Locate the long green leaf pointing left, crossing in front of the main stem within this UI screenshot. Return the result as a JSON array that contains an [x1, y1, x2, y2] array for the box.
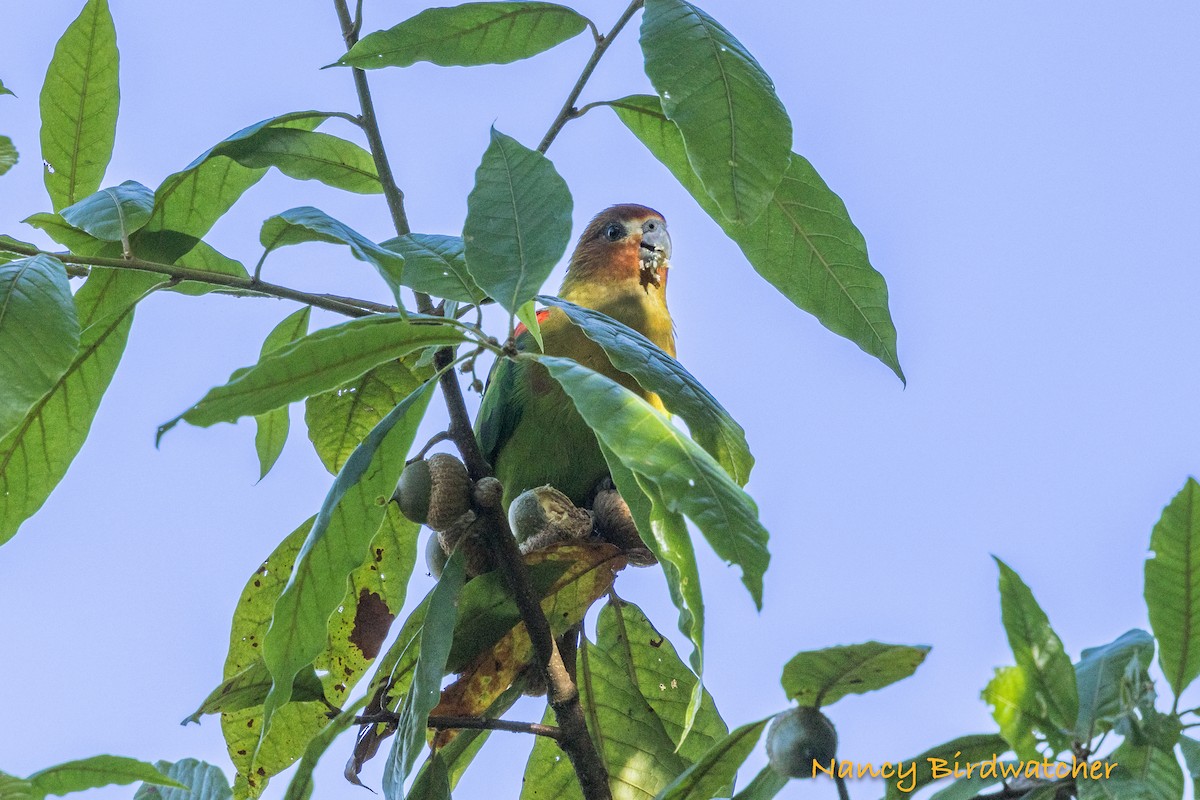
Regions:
[[158, 314, 463, 439]]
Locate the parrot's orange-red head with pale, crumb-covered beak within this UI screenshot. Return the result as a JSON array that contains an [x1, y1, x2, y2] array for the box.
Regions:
[[563, 203, 671, 296]]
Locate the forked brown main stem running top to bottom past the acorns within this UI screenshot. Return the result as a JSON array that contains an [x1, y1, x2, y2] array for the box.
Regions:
[[334, 0, 609, 800]]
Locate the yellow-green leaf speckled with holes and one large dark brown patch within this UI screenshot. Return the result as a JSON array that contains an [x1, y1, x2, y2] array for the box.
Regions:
[[221, 504, 418, 798]]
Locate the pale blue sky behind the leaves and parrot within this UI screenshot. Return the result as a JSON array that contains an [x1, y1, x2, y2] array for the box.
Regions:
[[0, 0, 1200, 800]]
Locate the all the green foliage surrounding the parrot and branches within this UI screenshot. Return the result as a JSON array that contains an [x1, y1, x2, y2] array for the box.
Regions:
[[0, 0, 1200, 800]]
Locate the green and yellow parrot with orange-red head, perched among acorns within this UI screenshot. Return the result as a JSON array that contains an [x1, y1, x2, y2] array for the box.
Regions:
[[475, 204, 676, 509]]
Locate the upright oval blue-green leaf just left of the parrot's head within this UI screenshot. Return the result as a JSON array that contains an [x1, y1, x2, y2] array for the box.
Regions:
[[462, 127, 571, 314]]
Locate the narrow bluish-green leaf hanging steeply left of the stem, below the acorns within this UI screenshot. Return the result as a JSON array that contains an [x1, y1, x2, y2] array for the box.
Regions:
[[383, 549, 467, 800]]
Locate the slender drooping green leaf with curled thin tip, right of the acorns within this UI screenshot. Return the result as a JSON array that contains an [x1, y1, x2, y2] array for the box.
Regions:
[[600, 443, 704, 736]]
